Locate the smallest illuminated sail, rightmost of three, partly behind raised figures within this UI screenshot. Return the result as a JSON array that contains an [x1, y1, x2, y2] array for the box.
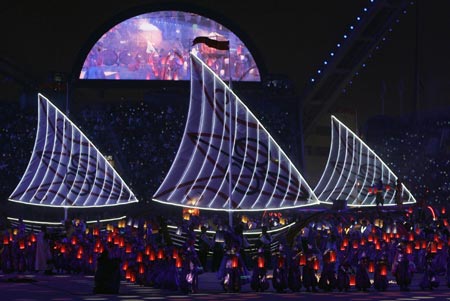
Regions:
[[314, 116, 416, 206]]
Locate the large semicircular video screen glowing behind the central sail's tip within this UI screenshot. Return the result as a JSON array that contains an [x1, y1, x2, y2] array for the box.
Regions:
[[79, 11, 261, 81]]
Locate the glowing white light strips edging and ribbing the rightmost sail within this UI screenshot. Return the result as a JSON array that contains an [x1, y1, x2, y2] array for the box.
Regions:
[[314, 115, 416, 207]]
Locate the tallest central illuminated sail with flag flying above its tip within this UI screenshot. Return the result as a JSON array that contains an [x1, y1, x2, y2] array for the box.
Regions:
[[153, 54, 319, 211]]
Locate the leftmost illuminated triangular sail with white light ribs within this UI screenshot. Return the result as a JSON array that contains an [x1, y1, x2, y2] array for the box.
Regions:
[[9, 94, 138, 208]]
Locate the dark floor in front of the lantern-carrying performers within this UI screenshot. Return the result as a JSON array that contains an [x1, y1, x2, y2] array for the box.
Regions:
[[0, 273, 450, 301]]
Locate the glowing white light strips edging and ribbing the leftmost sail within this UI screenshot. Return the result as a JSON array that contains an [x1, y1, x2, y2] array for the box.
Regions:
[[8, 93, 138, 208]]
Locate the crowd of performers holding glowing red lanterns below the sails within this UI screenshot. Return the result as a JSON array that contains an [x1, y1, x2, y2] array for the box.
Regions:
[[0, 204, 450, 293]]
